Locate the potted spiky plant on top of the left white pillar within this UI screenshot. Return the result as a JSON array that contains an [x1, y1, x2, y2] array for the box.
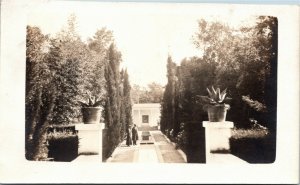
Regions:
[[78, 96, 103, 124]]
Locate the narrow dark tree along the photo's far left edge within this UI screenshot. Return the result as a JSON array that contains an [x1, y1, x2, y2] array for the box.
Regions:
[[25, 26, 57, 160]]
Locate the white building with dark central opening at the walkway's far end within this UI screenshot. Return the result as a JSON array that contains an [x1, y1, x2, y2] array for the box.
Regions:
[[132, 103, 160, 127]]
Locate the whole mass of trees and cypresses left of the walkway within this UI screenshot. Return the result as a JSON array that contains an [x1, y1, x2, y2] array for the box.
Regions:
[[25, 15, 131, 160]]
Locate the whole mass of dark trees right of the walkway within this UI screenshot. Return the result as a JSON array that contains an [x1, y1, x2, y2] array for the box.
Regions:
[[161, 16, 278, 149]]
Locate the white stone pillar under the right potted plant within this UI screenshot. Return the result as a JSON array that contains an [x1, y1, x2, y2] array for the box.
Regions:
[[203, 121, 234, 163]]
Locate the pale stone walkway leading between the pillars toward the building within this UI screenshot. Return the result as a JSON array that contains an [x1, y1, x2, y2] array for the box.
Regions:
[[106, 131, 186, 163]]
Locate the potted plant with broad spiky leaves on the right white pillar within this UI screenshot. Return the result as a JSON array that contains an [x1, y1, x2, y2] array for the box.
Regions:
[[198, 86, 231, 122]]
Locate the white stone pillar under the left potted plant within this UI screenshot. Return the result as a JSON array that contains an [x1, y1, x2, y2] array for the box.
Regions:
[[75, 123, 104, 162]]
